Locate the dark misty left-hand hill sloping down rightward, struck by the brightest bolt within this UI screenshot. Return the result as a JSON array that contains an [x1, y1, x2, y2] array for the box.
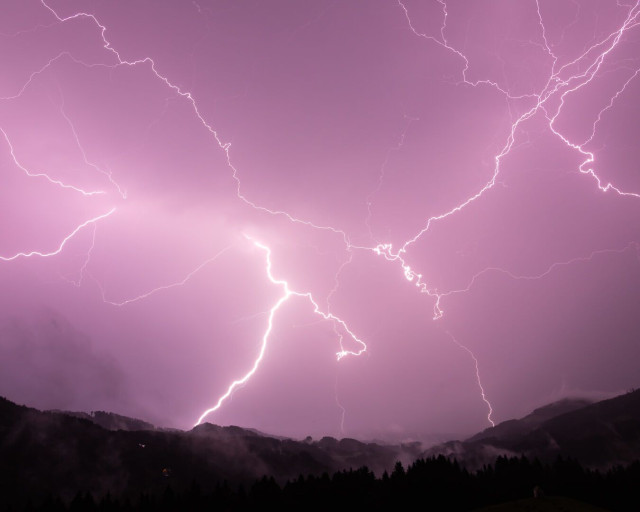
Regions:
[[0, 398, 420, 508]]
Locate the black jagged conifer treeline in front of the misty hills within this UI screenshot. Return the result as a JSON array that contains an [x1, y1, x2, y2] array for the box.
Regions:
[[14, 456, 640, 512]]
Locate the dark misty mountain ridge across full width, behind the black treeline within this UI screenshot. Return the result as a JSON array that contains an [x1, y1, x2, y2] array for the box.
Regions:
[[0, 391, 640, 507]]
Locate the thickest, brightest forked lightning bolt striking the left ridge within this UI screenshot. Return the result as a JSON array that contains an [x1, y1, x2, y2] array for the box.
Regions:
[[195, 237, 367, 425]]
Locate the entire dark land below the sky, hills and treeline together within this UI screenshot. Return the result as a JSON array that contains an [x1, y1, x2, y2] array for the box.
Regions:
[[0, 391, 640, 512]]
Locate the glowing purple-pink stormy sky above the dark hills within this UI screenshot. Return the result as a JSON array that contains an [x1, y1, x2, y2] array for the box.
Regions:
[[0, 0, 640, 439]]
